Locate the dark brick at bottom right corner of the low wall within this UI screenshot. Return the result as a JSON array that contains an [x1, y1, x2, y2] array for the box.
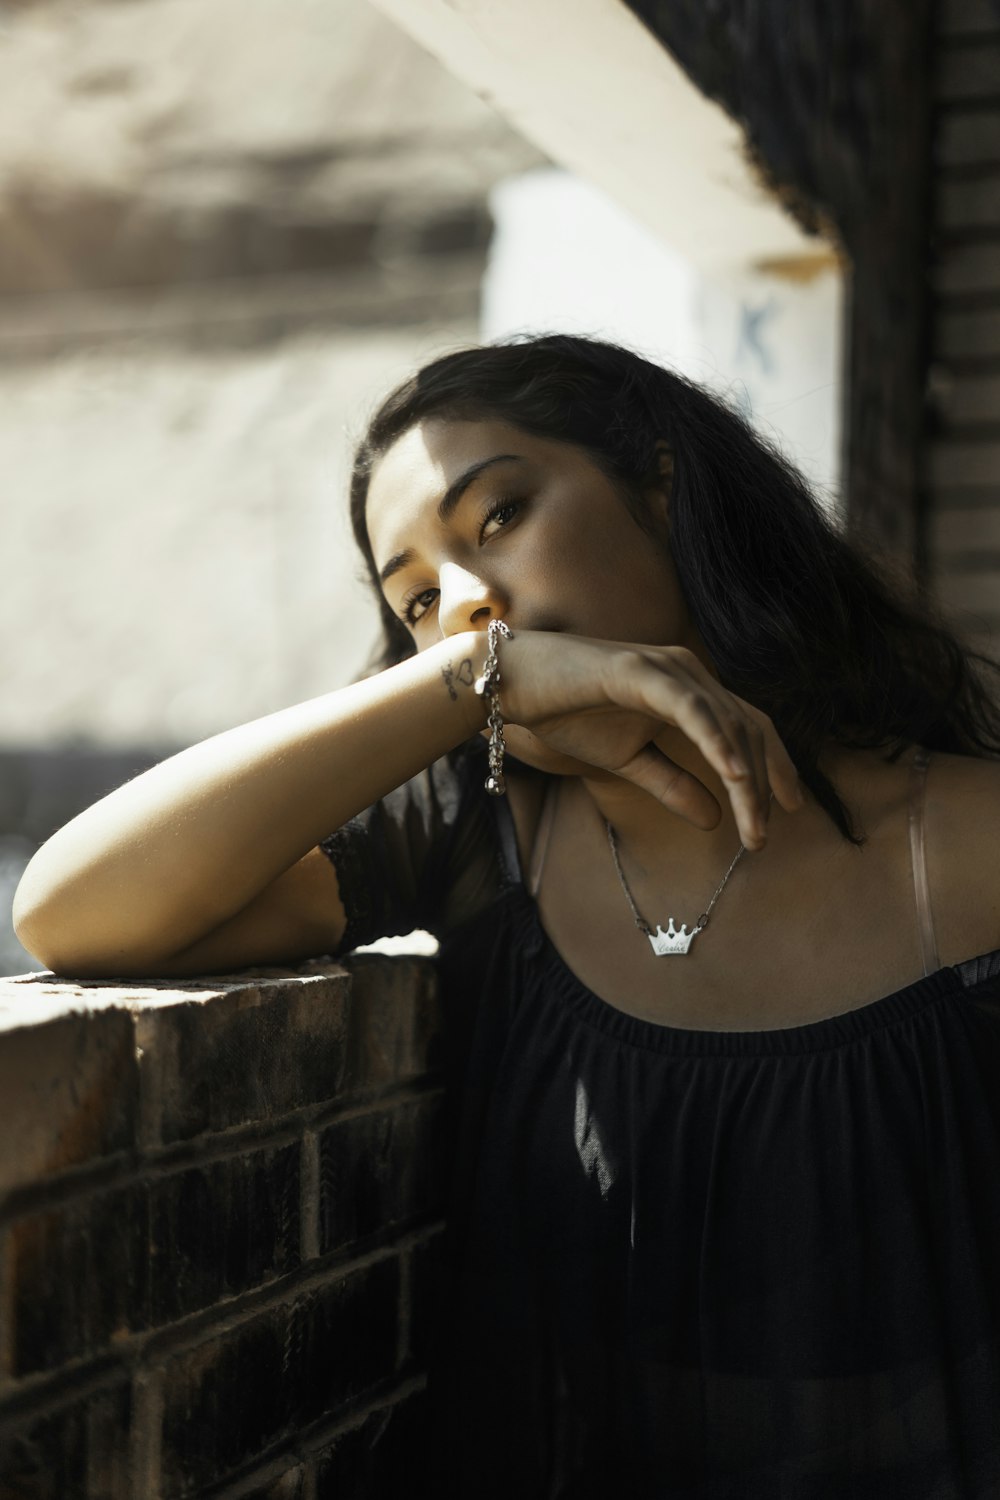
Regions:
[[316, 1391, 427, 1500]]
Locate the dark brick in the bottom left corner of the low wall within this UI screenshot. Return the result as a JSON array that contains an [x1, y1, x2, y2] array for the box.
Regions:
[[0, 1383, 133, 1500]]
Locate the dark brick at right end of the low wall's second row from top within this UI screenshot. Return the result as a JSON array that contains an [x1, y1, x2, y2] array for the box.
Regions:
[[319, 1094, 447, 1256]]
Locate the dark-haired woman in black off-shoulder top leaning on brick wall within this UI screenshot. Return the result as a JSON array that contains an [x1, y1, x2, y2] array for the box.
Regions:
[[16, 336, 1000, 1500]]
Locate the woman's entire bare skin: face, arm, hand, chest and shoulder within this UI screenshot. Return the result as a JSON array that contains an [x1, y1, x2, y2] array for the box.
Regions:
[[15, 422, 1000, 1008]]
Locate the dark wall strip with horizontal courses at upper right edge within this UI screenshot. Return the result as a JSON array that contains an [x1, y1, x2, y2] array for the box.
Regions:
[[925, 0, 1000, 654]]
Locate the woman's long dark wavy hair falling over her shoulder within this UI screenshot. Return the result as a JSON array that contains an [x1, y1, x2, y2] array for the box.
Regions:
[[351, 333, 1000, 846]]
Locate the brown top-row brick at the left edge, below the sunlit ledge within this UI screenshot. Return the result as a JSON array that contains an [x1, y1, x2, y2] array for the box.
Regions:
[[0, 1008, 138, 1194]]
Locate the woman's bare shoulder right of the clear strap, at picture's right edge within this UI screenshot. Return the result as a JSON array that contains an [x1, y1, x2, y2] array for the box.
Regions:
[[925, 752, 1000, 965]]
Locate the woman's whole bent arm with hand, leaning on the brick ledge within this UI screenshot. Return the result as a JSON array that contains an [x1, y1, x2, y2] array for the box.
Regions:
[[13, 630, 801, 975]]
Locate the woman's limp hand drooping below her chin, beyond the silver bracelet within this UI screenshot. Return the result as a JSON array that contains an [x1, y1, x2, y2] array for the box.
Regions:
[[499, 630, 804, 848]]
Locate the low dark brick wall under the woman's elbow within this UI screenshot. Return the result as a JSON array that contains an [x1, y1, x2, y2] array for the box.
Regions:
[[0, 954, 444, 1500]]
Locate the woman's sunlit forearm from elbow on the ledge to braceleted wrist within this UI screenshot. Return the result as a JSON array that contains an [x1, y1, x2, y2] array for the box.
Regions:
[[13, 632, 486, 968]]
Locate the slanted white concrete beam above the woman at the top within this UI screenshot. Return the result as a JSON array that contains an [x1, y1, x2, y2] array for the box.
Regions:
[[372, 0, 823, 267]]
